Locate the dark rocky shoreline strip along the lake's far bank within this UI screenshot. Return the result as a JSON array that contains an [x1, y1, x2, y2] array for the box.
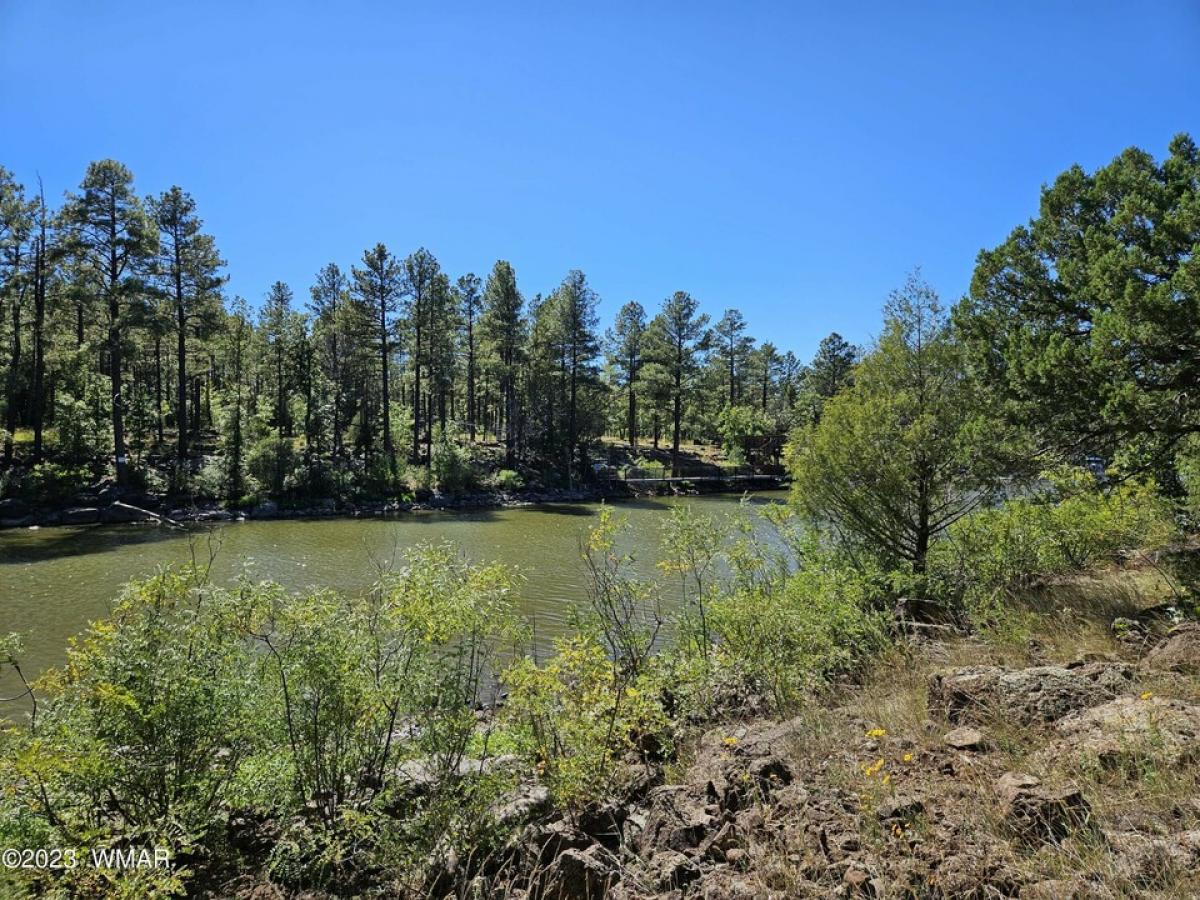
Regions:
[[0, 476, 785, 529]]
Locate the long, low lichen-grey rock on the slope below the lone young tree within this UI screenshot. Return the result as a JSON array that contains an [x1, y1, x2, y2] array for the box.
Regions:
[[929, 662, 1133, 725]]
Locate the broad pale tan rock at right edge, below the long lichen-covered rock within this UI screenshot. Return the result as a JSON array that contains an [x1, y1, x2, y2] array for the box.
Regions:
[[1045, 696, 1200, 767]]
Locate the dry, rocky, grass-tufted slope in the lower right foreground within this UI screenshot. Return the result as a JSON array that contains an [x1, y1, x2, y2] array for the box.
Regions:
[[225, 574, 1200, 900]]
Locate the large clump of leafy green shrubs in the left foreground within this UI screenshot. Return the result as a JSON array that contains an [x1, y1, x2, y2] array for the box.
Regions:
[[0, 547, 516, 896]]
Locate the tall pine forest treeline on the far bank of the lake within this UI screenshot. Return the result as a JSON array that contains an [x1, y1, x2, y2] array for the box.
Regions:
[[0, 160, 859, 500]]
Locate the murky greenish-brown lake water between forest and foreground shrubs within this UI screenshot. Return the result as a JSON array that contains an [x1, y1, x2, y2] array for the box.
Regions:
[[0, 491, 787, 691]]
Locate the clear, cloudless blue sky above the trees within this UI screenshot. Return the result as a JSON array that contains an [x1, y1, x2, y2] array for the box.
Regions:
[[0, 0, 1200, 358]]
